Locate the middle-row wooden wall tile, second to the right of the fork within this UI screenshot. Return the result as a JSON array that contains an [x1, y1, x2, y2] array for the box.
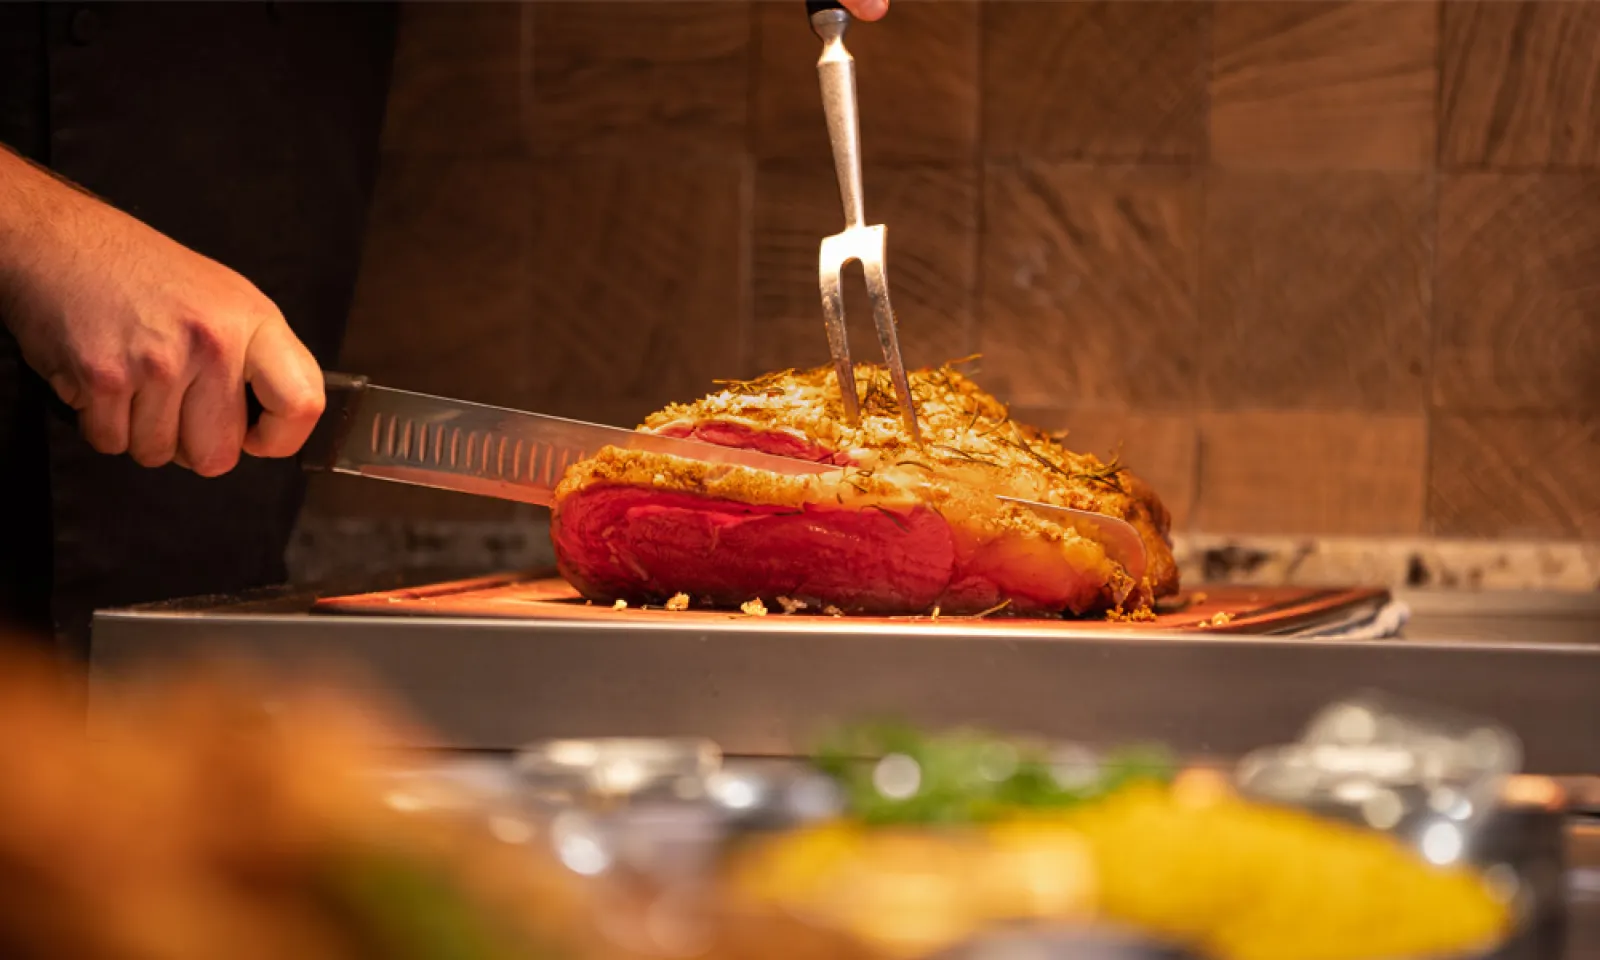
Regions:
[[1195, 171, 1432, 411]]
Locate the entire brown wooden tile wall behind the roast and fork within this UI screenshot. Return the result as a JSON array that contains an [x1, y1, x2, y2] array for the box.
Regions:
[[302, 0, 1600, 541]]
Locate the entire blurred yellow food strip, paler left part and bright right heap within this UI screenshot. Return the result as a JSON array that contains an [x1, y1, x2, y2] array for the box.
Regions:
[[733, 781, 1510, 960]]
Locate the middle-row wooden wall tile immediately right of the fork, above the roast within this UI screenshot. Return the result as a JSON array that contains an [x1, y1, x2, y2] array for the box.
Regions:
[[979, 163, 1202, 410]]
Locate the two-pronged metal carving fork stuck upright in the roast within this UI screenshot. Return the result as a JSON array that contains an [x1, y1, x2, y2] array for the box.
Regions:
[[805, 0, 922, 443]]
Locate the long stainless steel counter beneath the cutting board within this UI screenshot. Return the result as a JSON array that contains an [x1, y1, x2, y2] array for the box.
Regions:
[[91, 582, 1600, 774]]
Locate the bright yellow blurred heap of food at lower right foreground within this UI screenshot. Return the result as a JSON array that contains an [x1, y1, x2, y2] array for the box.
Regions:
[[1064, 784, 1510, 960]]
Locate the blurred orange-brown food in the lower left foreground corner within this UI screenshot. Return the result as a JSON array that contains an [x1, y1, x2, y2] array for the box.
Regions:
[[0, 658, 598, 960]]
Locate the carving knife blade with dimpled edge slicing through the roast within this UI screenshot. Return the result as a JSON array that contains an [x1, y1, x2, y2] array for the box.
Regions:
[[299, 373, 1147, 581]]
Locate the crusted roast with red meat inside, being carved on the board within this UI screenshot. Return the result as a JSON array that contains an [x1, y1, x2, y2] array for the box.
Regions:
[[552, 363, 1178, 616]]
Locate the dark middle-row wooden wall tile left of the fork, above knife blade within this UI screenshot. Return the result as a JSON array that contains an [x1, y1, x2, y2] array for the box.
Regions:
[[520, 158, 750, 426]]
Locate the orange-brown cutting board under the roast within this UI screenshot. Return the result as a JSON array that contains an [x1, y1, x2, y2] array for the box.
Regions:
[[314, 574, 1389, 634]]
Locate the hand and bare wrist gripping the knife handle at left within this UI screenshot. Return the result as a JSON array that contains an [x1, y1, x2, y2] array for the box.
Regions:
[[0, 150, 323, 477]]
